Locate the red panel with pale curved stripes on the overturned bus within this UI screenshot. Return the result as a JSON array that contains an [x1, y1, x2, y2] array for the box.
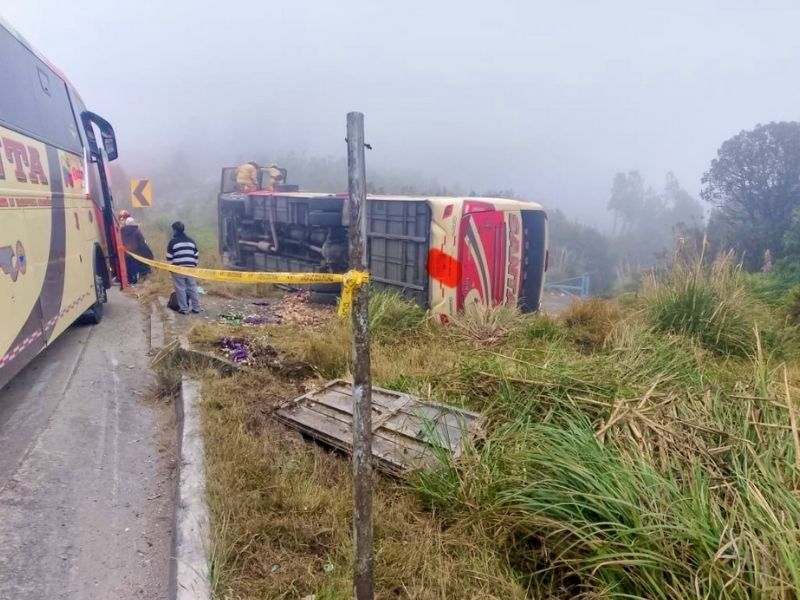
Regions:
[[456, 201, 506, 310]]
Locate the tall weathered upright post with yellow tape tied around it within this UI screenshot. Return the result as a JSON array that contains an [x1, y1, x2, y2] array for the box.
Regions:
[[347, 112, 375, 600]]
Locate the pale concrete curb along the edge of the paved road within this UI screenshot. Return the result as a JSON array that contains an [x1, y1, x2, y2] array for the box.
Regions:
[[170, 375, 211, 600]]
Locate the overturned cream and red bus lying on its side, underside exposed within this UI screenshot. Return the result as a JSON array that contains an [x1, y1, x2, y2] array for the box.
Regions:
[[218, 168, 547, 321]]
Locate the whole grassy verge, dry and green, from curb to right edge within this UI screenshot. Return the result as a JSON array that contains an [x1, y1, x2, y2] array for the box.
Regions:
[[193, 256, 800, 600]]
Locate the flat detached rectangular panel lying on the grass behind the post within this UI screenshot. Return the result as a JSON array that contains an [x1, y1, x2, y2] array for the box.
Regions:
[[273, 379, 483, 475]]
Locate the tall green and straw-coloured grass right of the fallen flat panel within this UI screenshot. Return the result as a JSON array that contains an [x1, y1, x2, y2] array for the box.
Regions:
[[412, 257, 800, 600]]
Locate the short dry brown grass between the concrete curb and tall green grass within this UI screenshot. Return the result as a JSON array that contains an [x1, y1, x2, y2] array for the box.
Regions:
[[203, 374, 526, 600]]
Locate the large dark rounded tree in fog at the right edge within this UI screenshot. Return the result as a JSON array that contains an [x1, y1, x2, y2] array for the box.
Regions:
[[701, 122, 800, 270]]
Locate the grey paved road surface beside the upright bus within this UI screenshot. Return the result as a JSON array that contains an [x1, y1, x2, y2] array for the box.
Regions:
[[0, 293, 175, 600]]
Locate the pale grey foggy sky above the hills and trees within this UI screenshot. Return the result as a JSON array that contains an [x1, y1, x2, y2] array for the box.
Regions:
[[0, 0, 800, 223]]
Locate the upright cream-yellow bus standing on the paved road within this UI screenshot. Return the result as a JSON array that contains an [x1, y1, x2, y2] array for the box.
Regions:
[[0, 20, 124, 388]]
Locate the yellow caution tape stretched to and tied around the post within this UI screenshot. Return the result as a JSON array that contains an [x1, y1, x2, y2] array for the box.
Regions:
[[128, 252, 369, 317]]
